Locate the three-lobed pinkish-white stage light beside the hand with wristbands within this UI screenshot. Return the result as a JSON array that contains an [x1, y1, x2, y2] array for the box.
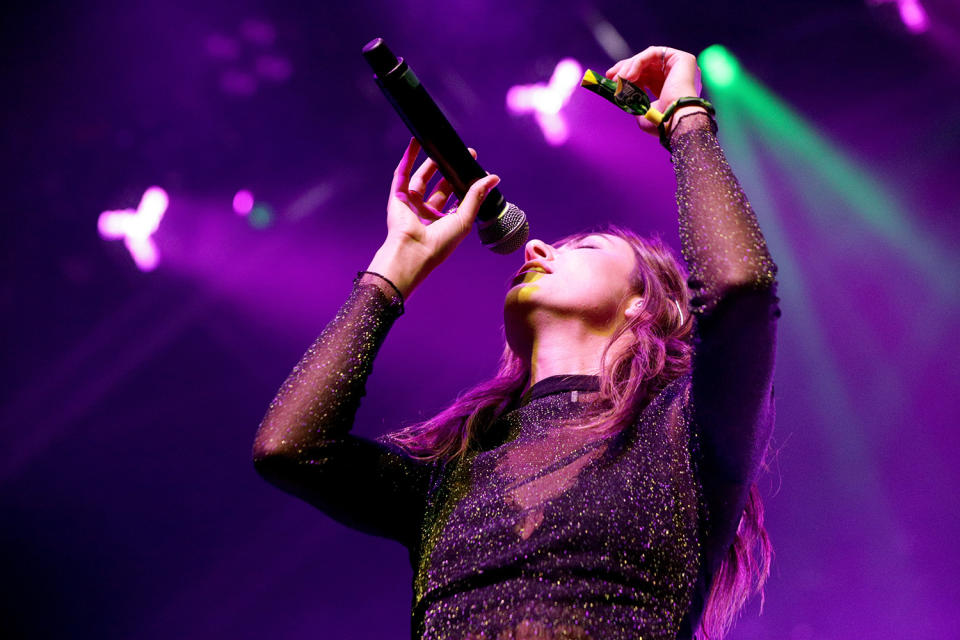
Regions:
[[507, 58, 583, 145]]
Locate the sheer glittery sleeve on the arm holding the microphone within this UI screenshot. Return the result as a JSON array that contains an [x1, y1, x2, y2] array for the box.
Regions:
[[253, 275, 433, 547]]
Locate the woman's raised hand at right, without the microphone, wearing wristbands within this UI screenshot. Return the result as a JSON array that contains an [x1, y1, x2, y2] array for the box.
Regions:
[[605, 47, 705, 135]]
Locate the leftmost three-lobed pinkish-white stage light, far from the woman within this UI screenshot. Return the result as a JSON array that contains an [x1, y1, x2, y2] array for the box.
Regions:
[[97, 187, 170, 271]]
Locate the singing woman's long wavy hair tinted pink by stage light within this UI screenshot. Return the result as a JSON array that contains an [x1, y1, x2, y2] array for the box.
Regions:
[[386, 224, 773, 640]]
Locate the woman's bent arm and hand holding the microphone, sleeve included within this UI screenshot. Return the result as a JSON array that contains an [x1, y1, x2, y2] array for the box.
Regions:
[[253, 142, 496, 546]]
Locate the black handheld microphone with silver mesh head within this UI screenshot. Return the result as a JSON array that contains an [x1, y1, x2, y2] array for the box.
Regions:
[[363, 38, 530, 254]]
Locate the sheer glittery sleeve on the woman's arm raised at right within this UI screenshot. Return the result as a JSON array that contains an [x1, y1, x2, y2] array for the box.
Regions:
[[672, 114, 780, 562]]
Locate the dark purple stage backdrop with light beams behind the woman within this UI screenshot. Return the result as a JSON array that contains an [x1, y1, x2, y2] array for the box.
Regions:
[[0, 0, 960, 640]]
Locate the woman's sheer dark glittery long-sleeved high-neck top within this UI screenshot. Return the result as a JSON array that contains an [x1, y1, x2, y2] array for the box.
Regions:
[[254, 116, 779, 640]]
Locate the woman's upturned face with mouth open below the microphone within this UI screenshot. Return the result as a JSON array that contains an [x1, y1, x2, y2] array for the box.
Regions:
[[504, 233, 639, 331]]
